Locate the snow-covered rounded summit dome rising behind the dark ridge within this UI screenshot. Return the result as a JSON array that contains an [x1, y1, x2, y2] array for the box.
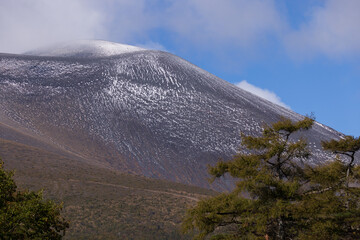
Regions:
[[25, 40, 145, 58]]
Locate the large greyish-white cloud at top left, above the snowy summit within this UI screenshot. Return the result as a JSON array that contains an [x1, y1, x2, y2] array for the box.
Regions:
[[0, 0, 156, 53]]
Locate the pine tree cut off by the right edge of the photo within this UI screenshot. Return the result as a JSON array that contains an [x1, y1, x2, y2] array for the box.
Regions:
[[302, 136, 360, 239]]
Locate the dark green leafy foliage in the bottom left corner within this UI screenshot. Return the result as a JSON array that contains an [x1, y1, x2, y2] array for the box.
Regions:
[[0, 159, 69, 239]]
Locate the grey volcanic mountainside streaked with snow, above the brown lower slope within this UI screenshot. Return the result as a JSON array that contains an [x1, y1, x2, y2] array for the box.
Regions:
[[0, 41, 341, 189]]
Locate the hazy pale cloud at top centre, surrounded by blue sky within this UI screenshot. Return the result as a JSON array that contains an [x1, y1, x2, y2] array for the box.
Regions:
[[164, 0, 282, 48]]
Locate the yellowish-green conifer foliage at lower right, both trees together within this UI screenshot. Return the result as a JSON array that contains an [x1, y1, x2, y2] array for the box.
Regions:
[[183, 118, 360, 239]]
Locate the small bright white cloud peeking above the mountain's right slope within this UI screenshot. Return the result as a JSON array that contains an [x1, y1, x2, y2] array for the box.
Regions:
[[235, 80, 291, 109]]
